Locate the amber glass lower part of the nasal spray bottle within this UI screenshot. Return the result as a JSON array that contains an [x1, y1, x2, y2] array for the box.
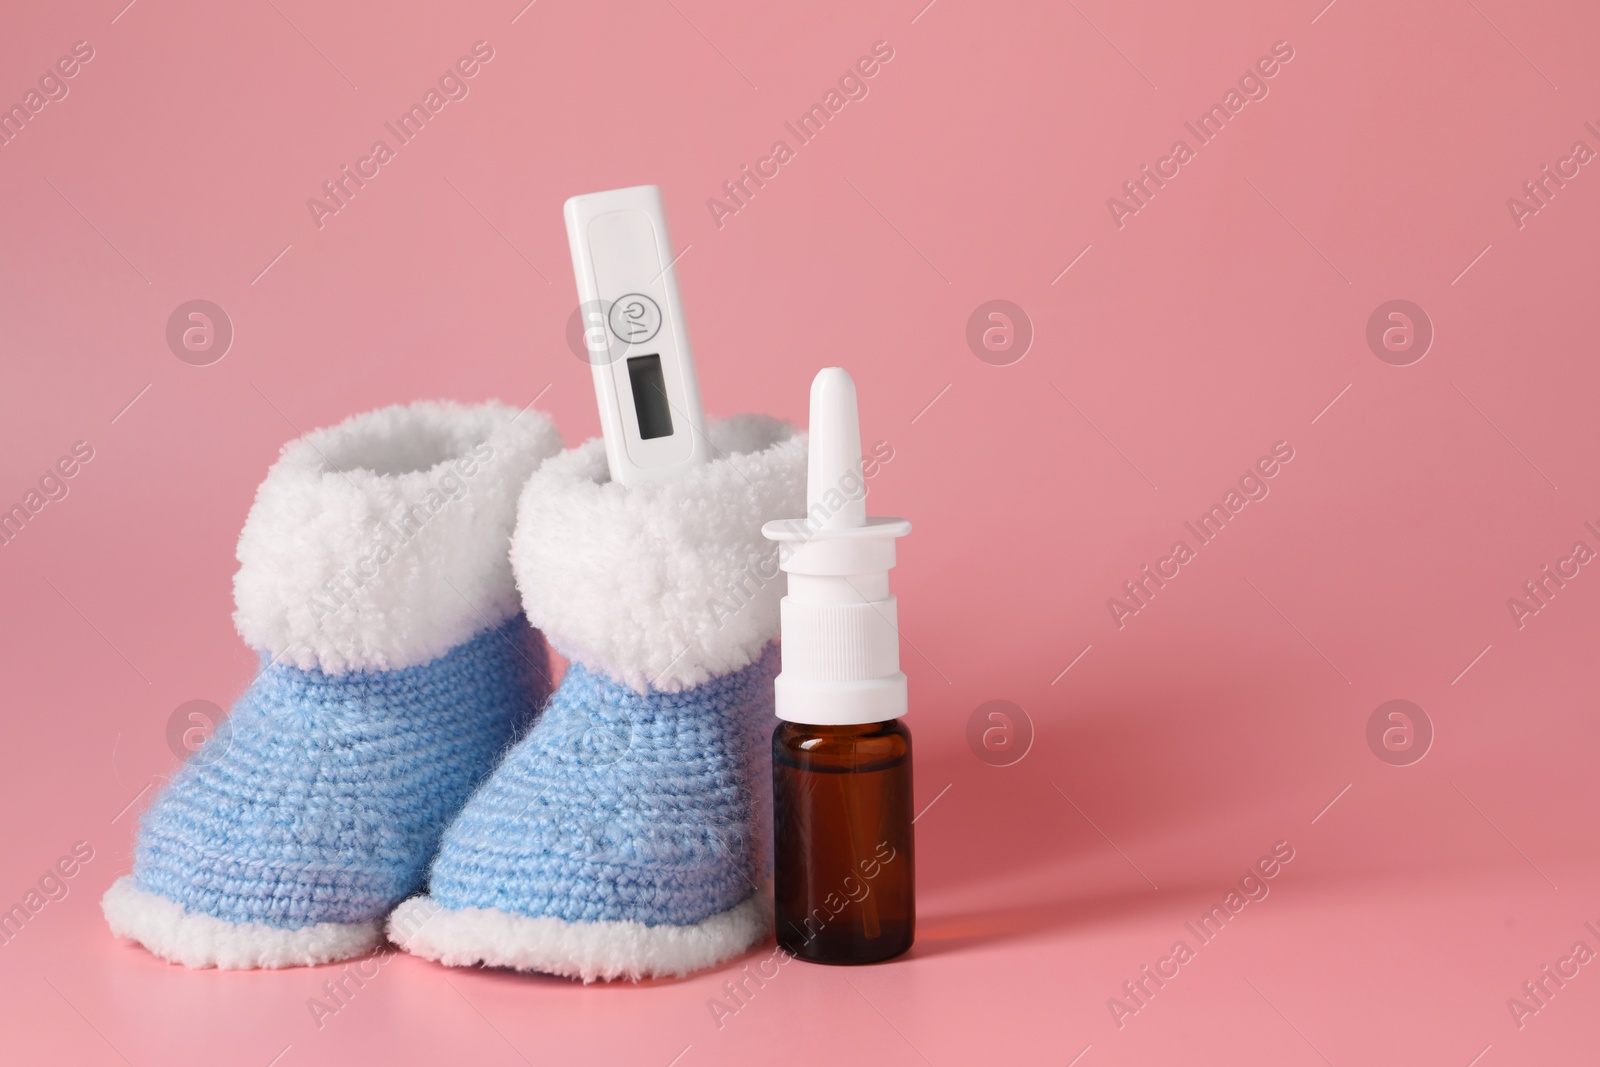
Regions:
[[773, 718, 917, 963]]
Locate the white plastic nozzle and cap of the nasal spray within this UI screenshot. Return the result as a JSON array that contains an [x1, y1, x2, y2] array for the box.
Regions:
[[762, 366, 910, 726]]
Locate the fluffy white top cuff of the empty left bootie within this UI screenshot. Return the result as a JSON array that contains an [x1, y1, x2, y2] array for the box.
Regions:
[[234, 402, 562, 673]]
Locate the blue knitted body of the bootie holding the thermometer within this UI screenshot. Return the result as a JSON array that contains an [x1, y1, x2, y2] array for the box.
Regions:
[[429, 645, 779, 926]]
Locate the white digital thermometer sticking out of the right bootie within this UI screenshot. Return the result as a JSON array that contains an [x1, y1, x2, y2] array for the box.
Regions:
[[563, 186, 710, 485]]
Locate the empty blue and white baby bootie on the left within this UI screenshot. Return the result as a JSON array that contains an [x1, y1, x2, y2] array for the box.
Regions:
[[102, 403, 560, 968]]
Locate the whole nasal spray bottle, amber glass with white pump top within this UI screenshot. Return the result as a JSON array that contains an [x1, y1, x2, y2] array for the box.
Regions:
[[762, 366, 917, 963]]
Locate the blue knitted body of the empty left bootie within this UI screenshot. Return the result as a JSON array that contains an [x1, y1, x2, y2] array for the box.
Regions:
[[133, 614, 549, 928]]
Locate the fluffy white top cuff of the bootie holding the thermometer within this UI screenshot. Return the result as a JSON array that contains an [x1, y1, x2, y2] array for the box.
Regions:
[[510, 416, 806, 693]]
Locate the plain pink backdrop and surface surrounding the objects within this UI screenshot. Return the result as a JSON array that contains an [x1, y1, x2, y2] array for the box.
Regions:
[[0, 0, 1600, 1067]]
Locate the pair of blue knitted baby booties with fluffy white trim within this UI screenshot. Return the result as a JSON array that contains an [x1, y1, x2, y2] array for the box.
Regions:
[[102, 402, 806, 982]]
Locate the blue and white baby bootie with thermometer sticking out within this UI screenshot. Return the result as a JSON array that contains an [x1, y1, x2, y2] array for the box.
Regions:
[[389, 416, 806, 982]]
